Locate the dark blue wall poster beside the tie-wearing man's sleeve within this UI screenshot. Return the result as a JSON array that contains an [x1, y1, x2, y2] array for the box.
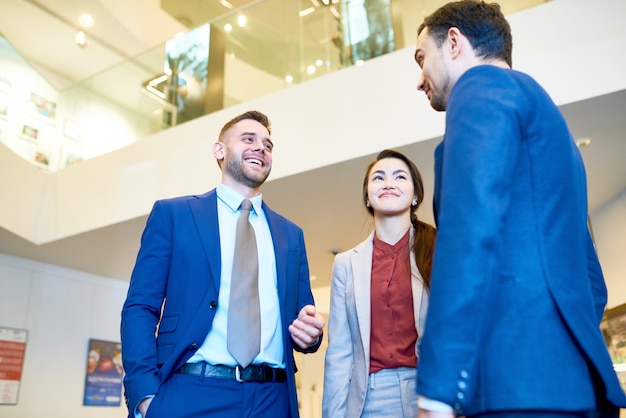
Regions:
[[83, 339, 124, 406]]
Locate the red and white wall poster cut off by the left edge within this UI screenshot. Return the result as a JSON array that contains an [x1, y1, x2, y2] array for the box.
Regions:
[[0, 327, 28, 405]]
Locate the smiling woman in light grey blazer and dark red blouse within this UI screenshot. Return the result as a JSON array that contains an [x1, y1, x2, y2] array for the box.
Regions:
[[322, 150, 436, 418]]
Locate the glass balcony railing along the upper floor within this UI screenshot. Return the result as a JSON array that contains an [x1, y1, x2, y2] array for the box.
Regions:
[[0, 0, 546, 171]]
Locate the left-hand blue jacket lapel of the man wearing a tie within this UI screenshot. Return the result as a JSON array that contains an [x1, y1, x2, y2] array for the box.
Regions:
[[189, 189, 222, 289]]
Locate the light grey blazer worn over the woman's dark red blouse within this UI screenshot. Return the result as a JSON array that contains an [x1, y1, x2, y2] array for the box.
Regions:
[[322, 229, 428, 418]]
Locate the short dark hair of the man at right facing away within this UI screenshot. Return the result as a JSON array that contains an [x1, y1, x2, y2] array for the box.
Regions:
[[417, 0, 513, 67]]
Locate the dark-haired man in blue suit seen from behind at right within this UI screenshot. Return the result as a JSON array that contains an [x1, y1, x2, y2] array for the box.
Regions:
[[415, 0, 626, 418]]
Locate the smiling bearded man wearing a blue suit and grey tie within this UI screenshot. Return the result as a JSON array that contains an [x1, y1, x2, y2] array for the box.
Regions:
[[121, 111, 324, 418]]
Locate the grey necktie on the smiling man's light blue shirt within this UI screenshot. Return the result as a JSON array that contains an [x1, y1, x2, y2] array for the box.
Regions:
[[227, 199, 261, 367]]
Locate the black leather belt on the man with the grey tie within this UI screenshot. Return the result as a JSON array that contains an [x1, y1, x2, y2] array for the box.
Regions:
[[176, 363, 287, 382]]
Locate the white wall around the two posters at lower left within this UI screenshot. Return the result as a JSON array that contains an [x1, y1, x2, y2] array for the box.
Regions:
[[0, 254, 128, 418]]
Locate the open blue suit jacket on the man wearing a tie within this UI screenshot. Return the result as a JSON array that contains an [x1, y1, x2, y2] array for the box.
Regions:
[[121, 190, 321, 417]]
